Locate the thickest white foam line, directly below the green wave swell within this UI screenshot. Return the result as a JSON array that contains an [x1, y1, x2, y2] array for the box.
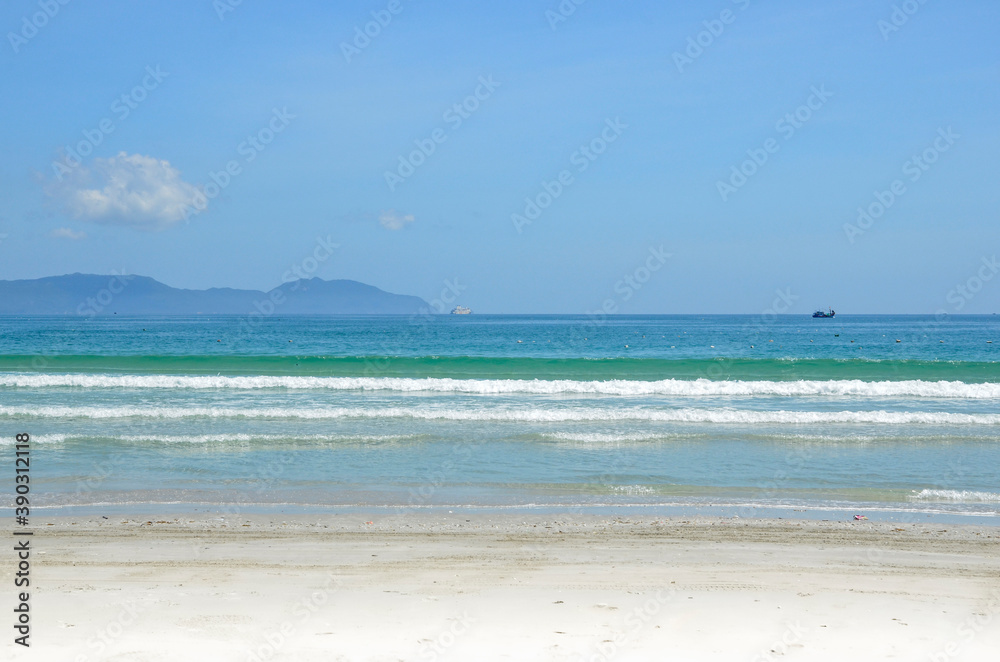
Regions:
[[0, 373, 1000, 400]]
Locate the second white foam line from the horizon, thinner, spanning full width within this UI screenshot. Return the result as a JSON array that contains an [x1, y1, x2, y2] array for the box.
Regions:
[[0, 406, 1000, 426]]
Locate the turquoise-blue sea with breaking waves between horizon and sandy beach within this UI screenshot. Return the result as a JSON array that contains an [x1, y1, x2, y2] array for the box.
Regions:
[[0, 314, 1000, 525]]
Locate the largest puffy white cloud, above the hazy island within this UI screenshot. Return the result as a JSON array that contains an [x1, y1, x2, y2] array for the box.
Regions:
[[48, 152, 200, 230]]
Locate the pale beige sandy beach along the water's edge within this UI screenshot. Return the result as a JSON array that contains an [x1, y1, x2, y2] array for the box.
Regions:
[[0, 513, 1000, 662]]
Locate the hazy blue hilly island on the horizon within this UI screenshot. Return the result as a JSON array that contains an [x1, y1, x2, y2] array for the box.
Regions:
[[0, 273, 432, 317]]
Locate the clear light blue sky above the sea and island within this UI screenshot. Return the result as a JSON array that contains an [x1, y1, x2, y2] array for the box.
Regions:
[[0, 0, 1000, 313]]
